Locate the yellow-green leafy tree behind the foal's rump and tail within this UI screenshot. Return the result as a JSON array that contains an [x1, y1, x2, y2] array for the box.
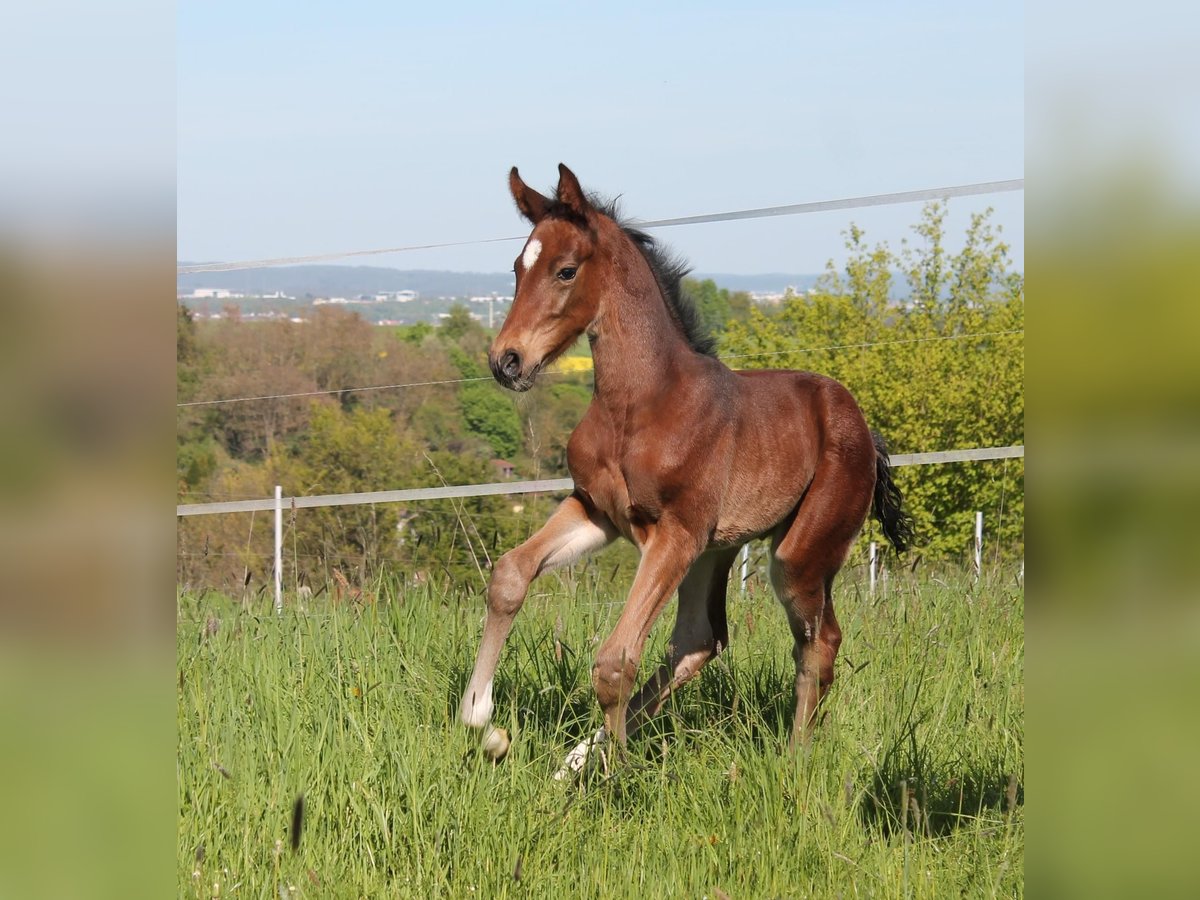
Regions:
[[721, 203, 1025, 558]]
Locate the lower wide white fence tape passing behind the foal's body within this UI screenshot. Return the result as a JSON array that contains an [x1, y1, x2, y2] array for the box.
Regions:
[[175, 444, 1025, 516]]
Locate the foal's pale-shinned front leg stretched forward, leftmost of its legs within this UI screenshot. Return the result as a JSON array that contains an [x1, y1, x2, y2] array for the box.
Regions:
[[458, 494, 617, 760]]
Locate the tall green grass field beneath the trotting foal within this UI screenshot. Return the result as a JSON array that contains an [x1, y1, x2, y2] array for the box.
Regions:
[[176, 572, 1025, 900]]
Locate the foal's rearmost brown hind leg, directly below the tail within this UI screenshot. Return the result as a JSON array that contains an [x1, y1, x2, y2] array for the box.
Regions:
[[770, 472, 871, 746]]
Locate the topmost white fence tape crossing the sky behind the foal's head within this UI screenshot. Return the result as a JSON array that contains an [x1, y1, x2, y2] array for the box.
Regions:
[[175, 178, 1025, 275]]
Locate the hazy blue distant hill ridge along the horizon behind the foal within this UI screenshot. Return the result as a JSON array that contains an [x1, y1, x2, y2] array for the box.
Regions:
[[178, 265, 817, 299]]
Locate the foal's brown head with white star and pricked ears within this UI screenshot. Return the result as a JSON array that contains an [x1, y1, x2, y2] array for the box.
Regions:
[[487, 164, 600, 391]]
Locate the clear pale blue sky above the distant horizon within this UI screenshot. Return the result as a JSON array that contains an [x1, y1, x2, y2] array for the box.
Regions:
[[176, 0, 1024, 274]]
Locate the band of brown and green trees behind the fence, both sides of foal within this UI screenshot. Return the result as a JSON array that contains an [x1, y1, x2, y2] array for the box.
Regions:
[[176, 204, 1024, 593]]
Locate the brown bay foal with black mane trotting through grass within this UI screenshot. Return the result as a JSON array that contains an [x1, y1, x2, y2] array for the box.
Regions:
[[461, 166, 911, 776]]
